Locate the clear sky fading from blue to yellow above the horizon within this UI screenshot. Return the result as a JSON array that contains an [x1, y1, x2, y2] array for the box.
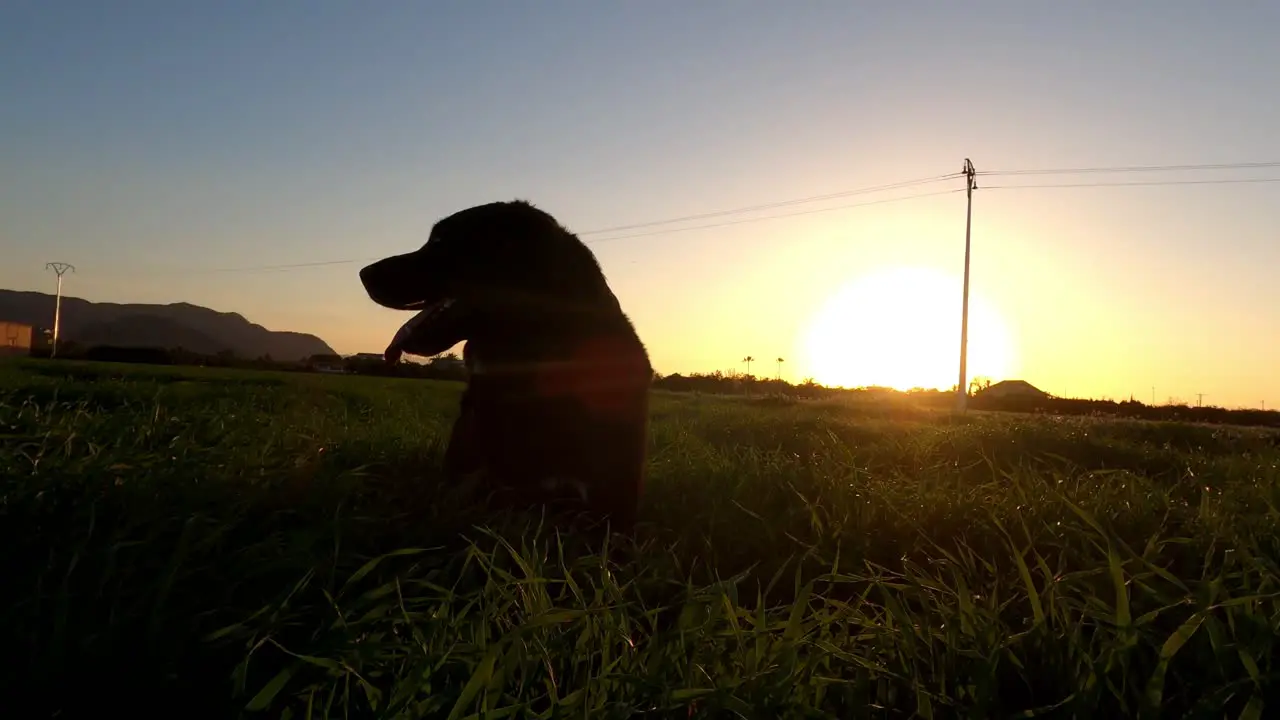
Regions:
[[0, 0, 1280, 406]]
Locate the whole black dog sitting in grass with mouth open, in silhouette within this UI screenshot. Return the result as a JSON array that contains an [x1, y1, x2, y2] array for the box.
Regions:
[[361, 201, 653, 528]]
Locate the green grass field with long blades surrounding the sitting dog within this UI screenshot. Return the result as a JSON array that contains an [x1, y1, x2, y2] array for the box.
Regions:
[[0, 361, 1280, 717]]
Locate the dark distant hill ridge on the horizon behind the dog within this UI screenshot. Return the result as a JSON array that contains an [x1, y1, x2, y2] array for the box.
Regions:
[[0, 290, 335, 360]]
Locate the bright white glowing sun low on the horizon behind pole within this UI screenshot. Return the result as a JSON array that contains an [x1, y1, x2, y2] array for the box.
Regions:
[[805, 268, 1015, 389]]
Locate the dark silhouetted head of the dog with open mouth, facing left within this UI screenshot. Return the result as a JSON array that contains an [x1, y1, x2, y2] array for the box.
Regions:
[[360, 200, 617, 355]]
